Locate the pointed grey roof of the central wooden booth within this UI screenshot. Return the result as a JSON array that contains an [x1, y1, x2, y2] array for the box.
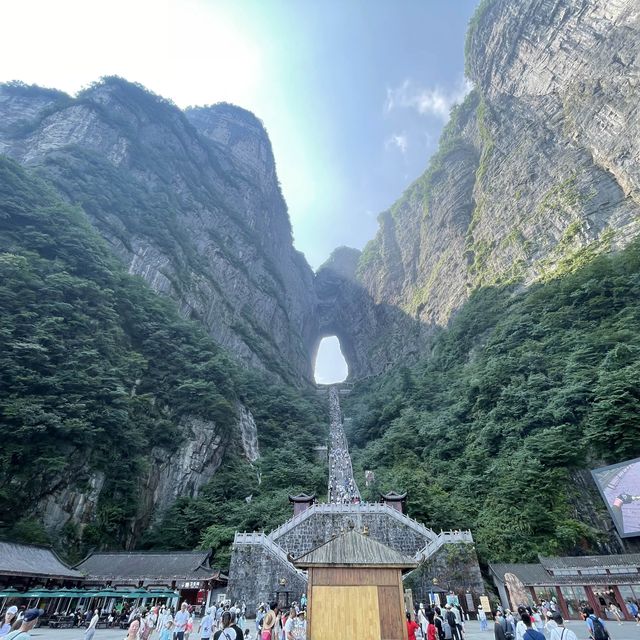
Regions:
[[294, 531, 417, 569]]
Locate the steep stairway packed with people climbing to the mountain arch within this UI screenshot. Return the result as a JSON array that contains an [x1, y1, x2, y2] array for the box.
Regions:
[[328, 387, 360, 504]]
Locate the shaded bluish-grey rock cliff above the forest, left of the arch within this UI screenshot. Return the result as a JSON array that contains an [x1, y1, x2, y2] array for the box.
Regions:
[[0, 79, 314, 383]]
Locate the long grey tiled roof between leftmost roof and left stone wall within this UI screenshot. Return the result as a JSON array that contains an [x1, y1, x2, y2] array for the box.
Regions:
[[76, 550, 219, 581]]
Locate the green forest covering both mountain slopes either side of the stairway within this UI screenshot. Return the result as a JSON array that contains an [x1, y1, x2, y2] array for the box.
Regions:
[[0, 148, 640, 567]]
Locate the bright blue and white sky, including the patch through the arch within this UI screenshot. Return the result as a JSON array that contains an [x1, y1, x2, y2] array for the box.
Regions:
[[0, 0, 477, 381]]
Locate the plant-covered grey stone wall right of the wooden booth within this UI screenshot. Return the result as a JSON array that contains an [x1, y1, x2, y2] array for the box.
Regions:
[[404, 543, 485, 610]]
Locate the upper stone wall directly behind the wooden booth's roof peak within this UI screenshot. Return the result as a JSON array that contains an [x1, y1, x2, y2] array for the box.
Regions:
[[273, 507, 429, 558]]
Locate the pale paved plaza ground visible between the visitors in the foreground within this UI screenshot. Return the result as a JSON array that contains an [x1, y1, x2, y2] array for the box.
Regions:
[[31, 620, 640, 640]]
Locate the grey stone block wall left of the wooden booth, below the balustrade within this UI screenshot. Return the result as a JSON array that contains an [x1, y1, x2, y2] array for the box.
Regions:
[[227, 544, 307, 614]]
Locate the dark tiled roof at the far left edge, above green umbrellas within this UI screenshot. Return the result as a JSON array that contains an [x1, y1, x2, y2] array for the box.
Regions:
[[0, 541, 82, 579]]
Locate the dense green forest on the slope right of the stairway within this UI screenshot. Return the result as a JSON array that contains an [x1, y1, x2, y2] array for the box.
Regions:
[[345, 242, 640, 561]]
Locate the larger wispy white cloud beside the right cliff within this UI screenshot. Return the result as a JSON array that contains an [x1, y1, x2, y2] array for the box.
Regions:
[[384, 78, 472, 121]]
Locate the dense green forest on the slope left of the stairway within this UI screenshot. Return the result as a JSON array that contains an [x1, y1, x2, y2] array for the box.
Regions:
[[0, 157, 325, 563]]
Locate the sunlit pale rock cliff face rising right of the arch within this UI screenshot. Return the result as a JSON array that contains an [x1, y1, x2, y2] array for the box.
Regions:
[[321, 0, 640, 372]]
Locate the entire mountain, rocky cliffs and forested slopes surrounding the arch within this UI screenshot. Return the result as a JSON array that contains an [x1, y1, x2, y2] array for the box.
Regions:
[[0, 0, 640, 565]]
